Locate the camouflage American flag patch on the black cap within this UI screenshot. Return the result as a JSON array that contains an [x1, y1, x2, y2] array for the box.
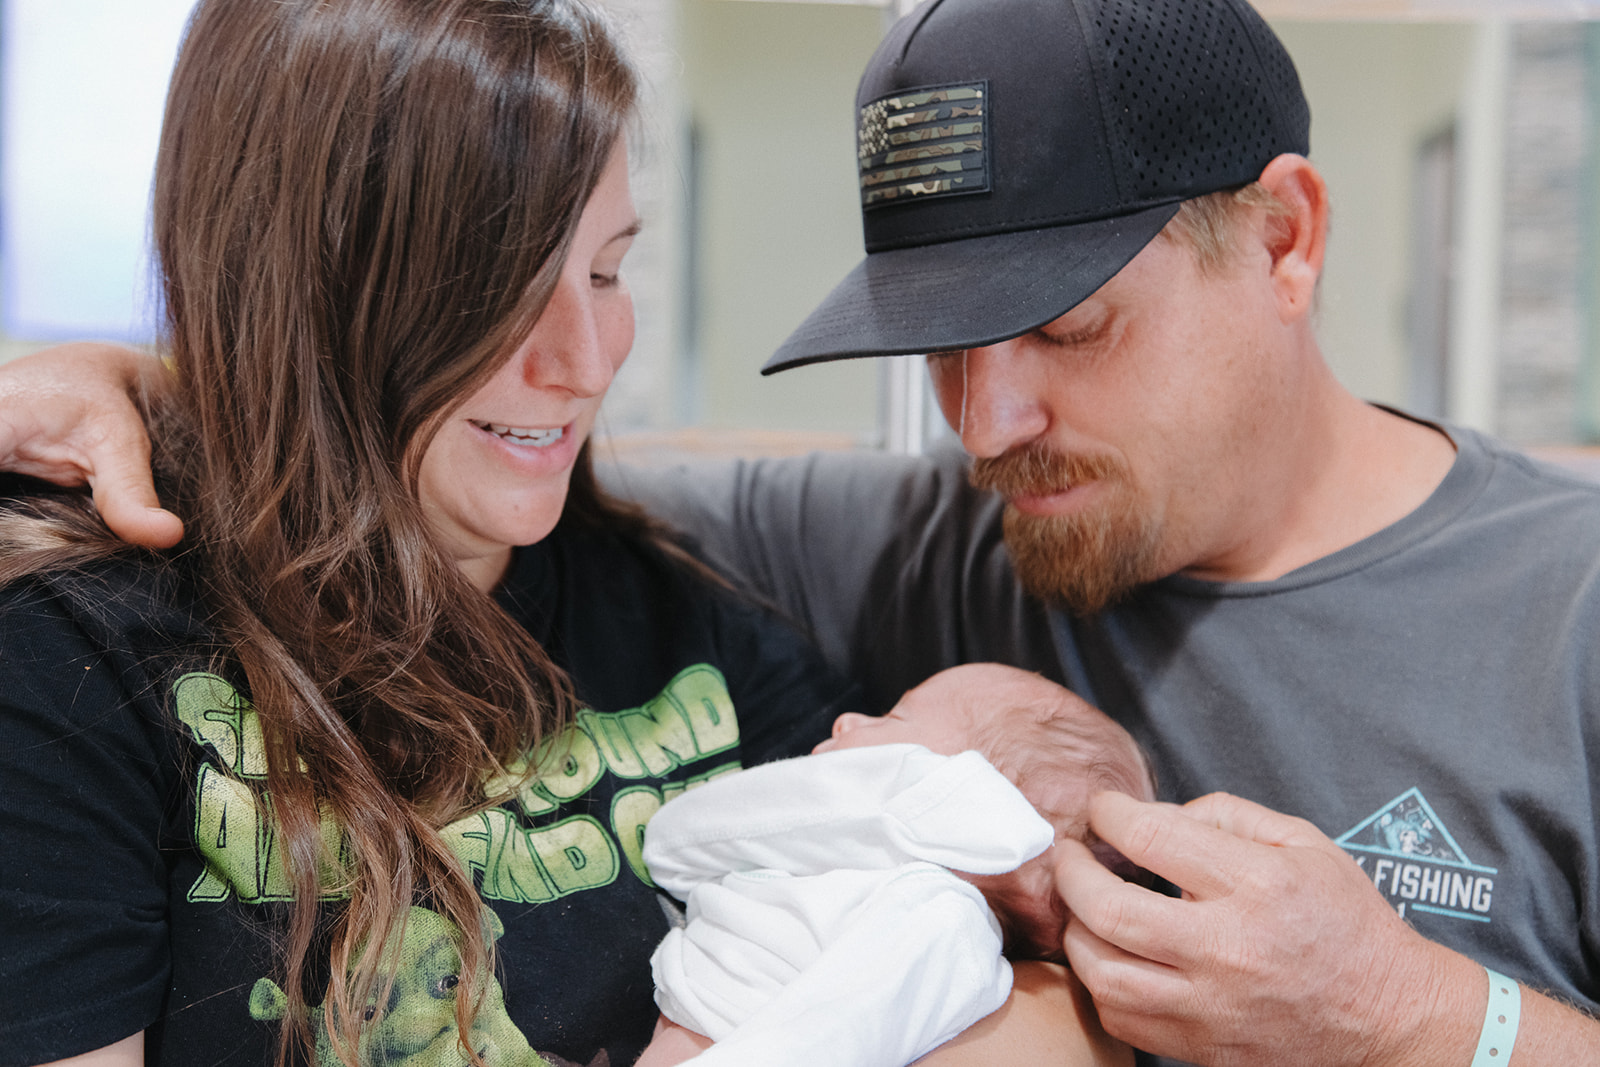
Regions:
[[856, 82, 989, 208]]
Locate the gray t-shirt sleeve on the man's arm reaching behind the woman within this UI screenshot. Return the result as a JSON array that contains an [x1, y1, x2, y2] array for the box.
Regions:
[[606, 451, 1062, 712]]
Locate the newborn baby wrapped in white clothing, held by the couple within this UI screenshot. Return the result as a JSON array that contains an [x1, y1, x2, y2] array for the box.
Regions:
[[638, 664, 1155, 1067]]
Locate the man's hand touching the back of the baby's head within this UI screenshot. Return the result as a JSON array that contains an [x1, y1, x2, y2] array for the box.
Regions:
[[1056, 793, 1478, 1067]]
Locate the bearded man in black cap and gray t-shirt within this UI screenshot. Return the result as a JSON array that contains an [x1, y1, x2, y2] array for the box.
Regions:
[[0, 0, 1600, 1067]]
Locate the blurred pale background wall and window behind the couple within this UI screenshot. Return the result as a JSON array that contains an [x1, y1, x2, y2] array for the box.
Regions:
[[0, 0, 1600, 446]]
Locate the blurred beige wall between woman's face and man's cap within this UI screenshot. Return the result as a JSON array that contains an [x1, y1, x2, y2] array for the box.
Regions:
[[682, 0, 885, 437]]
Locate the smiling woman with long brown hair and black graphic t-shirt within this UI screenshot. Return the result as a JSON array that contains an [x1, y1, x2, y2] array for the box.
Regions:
[[0, 0, 840, 1065]]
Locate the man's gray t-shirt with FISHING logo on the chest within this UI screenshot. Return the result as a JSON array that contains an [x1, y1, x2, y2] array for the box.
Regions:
[[601, 430, 1600, 1062]]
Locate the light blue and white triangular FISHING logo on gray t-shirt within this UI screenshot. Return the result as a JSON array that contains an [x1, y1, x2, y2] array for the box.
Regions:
[[1334, 789, 1498, 923]]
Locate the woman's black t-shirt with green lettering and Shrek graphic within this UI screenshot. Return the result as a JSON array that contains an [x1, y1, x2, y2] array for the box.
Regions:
[[0, 511, 856, 1067]]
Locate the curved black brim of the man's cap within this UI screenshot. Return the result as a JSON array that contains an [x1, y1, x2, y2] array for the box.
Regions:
[[762, 203, 1179, 374]]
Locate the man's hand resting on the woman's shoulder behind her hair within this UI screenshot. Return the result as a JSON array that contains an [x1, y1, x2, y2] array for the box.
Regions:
[[0, 342, 184, 549]]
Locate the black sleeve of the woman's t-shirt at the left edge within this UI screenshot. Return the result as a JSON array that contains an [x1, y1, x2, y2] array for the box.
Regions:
[[0, 582, 168, 1064]]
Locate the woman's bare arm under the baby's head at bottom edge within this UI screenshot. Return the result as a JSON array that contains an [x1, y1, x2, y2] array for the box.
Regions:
[[917, 960, 1133, 1067]]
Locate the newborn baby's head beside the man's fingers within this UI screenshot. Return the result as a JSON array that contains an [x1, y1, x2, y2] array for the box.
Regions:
[[816, 664, 1155, 960]]
